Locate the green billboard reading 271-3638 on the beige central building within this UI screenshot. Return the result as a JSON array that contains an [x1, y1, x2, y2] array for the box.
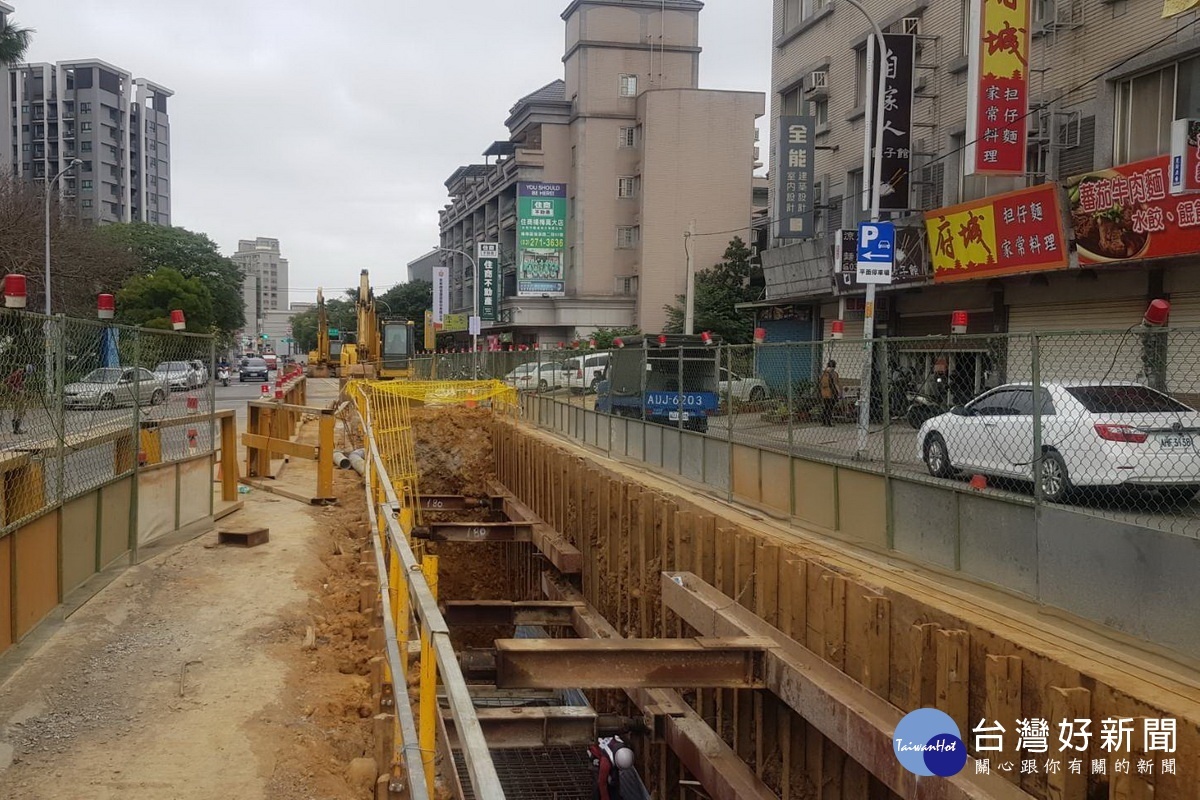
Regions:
[[517, 182, 566, 297]]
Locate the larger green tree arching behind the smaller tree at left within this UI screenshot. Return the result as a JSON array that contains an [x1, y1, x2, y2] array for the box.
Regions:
[[98, 222, 246, 347]]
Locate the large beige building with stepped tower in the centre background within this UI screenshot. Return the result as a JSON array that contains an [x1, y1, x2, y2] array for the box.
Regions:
[[440, 0, 766, 347]]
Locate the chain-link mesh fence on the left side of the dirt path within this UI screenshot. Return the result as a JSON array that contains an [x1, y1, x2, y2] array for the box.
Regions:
[[0, 309, 215, 528]]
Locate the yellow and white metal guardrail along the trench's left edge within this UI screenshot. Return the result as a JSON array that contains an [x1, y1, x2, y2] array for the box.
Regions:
[[347, 381, 505, 800]]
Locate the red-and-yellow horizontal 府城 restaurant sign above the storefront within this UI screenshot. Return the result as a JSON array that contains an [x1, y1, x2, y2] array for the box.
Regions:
[[925, 184, 1067, 283]]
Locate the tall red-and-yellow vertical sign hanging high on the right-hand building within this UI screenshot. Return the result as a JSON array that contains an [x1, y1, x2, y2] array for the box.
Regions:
[[966, 0, 1032, 175]]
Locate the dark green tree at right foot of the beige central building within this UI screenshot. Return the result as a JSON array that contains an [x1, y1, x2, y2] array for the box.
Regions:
[[664, 236, 755, 344]]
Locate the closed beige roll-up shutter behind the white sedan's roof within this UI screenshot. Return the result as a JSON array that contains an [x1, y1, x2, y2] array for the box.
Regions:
[[1007, 297, 1146, 381]]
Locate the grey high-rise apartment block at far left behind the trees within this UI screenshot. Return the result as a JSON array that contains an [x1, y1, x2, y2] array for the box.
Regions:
[[0, 44, 174, 225]]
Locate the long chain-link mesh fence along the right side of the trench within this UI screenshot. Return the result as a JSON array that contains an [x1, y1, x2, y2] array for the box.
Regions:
[[419, 326, 1200, 536]]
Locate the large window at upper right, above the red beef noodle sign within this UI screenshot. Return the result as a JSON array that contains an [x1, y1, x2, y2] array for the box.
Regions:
[[1112, 56, 1200, 164]]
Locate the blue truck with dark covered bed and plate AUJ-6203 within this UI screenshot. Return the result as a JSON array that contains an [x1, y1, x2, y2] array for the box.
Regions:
[[596, 333, 719, 433]]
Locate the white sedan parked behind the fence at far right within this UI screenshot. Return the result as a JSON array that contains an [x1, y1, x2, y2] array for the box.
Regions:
[[917, 381, 1200, 503]]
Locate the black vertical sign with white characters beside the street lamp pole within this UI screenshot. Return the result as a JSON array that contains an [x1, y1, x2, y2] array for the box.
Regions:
[[863, 34, 917, 211]]
